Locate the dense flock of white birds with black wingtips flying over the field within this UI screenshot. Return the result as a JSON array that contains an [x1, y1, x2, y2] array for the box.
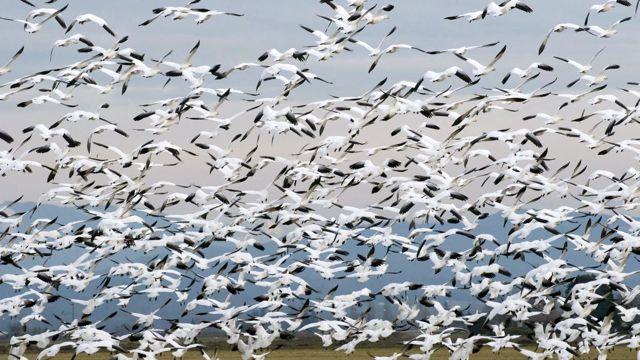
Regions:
[[0, 0, 640, 360]]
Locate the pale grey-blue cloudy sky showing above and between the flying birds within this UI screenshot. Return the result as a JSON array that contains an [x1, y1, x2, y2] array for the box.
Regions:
[[0, 0, 640, 338]]
